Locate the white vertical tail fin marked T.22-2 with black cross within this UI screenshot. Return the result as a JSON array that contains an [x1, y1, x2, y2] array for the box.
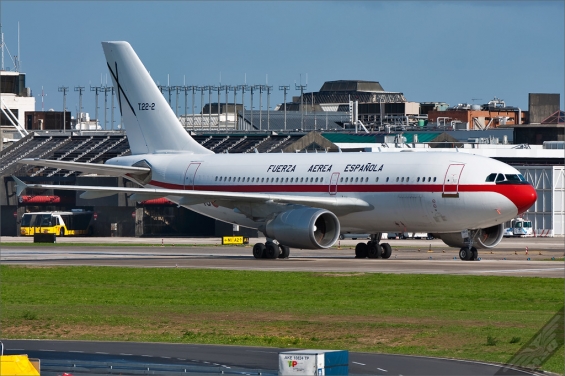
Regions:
[[102, 42, 213, 154]]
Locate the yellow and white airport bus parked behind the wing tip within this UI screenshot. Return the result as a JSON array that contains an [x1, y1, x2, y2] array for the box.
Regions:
[[20, 210, 94, 236]]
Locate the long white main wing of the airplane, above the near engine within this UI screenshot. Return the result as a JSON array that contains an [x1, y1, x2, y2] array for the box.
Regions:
[[12, 176, 373, 214]]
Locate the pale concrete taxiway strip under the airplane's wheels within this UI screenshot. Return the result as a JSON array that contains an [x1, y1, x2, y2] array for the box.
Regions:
[[0, 238, 565, 278]]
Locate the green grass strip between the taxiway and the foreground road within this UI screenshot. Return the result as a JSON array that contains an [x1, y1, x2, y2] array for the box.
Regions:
[[0, 266, 564, 373]]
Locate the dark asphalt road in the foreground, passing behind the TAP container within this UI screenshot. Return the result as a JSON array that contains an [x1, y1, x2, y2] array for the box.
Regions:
[[3, 340, 533, 376]]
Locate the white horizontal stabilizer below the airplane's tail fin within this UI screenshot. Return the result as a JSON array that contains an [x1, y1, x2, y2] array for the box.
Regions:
[[18, 158, 151, 176]]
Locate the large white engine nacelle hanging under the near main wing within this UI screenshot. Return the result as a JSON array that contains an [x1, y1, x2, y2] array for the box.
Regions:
[[261, 208, 340, 249]]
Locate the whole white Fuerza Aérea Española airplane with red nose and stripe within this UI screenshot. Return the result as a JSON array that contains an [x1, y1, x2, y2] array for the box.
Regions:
[[14, 42, 537, 260]]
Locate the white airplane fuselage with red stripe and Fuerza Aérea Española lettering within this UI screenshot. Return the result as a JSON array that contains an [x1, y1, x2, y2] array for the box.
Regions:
[[107, 152, 533, 233]]
